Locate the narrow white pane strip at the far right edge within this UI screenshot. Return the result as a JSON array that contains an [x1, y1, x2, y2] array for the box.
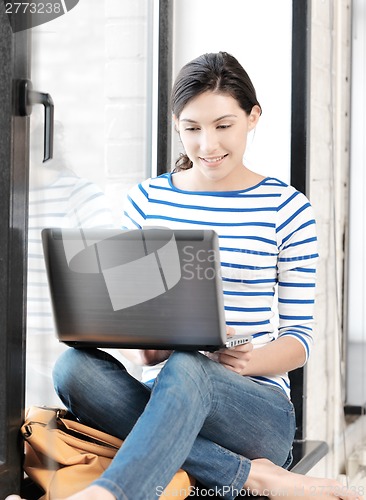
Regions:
[[346, 0, 366, 407]]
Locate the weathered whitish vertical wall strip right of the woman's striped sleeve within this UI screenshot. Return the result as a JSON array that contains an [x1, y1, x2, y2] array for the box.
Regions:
[[306, 0, 358, 476]]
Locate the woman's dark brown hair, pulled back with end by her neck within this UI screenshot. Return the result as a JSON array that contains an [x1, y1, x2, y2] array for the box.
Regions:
[[171, 52, 261, 171]]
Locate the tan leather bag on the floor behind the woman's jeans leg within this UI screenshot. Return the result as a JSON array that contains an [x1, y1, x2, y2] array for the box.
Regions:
[[21, 406, 194, 500]]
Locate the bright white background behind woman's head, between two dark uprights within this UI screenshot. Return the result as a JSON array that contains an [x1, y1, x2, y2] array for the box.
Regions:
[[173, 0, 292, 182]]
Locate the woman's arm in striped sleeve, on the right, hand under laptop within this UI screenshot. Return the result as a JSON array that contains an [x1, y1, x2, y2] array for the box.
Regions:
[[219, 191, 318, 376]]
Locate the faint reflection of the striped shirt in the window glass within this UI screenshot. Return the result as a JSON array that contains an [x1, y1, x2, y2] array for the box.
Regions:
[[27, 173, 112, 334]]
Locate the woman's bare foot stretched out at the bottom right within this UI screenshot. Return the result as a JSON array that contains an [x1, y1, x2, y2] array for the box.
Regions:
[[244, 458, 363, 500]]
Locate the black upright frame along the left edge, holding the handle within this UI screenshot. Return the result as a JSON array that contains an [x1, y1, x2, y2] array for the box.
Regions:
[[0, 1, 30, 500]]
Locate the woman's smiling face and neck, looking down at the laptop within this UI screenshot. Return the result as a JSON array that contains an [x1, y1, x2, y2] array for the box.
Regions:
[[174, 92, 260, 188]]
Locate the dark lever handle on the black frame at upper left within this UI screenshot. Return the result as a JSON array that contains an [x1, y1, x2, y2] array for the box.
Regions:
[[17, 80, 54, 162]]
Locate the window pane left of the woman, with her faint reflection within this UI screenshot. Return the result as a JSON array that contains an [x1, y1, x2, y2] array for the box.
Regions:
[[26, 0, 152, 405]]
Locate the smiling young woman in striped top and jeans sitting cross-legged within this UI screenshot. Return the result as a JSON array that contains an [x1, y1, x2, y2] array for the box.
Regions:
[[7, 52, 356, 500]]
